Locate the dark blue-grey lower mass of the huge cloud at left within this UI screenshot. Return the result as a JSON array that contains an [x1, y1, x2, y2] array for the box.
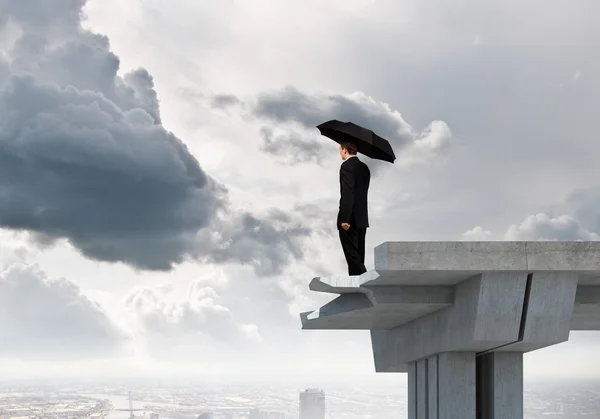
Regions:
[[0, 71, 224, 269]]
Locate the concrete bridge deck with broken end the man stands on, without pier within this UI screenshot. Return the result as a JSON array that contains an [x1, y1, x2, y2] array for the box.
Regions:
[[301, 242, 600, 334]]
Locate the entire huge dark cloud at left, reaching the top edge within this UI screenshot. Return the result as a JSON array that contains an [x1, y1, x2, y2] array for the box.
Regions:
[[0, 0, 304, 274]]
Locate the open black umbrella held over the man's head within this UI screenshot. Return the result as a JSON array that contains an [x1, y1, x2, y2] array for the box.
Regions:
[[317, 119, 396, 163]]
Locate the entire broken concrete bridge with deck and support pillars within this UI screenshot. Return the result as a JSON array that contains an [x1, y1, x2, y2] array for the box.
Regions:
[[300, 242, 600, 419]]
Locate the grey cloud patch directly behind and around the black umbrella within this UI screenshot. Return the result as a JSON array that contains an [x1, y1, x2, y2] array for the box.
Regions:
[[213, 86, 451, 170]]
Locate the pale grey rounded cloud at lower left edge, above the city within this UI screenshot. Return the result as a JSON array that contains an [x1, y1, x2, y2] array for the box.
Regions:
[[0, 265, 130, 360]]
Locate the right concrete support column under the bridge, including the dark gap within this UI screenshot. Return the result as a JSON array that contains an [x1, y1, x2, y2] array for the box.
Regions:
[[477, 352, 523, 419]]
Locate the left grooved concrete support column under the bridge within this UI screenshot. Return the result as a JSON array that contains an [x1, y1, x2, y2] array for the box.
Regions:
[[408, 352, 477, 419]]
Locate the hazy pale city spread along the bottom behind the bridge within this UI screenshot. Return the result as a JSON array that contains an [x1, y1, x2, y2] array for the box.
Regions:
[[0, 380, 600, 419]]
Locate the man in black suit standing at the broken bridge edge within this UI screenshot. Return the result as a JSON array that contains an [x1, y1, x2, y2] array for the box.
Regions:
[[337, 143, 371, 275]]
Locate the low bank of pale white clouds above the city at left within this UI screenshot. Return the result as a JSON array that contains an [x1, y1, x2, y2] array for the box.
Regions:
[[0, 261, 263, 362]]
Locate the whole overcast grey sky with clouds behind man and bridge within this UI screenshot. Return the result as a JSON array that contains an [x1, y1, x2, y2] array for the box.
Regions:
[[0, 0, 600, 382]]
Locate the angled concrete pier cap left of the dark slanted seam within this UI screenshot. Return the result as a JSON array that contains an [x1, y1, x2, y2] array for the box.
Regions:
[[371, 273, 527, 372]]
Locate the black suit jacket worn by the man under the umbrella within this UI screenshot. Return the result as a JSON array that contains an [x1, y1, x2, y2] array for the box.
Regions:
[[337, 157, 371, 229]]
